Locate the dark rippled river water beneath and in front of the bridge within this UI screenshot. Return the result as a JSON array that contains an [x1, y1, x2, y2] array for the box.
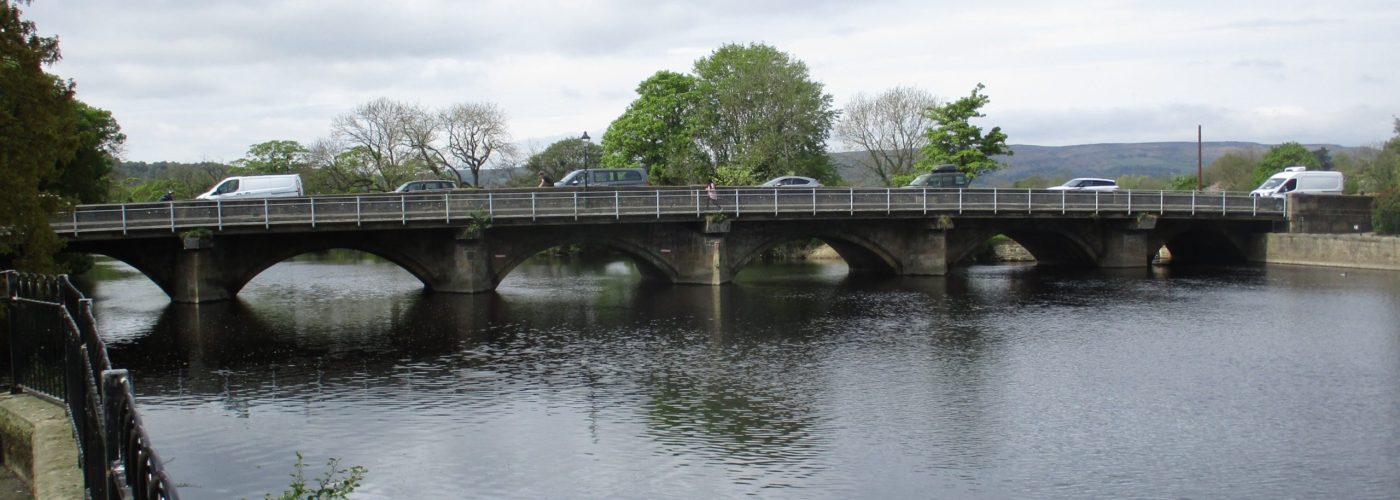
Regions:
[[79, 254, 1400, 499]]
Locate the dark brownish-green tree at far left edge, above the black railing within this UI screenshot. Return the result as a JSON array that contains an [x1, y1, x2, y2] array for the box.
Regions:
[[0, 0, 78, 272]]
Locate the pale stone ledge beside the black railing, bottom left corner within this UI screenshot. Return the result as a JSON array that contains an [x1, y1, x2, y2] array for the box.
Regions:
[[0, 394, 84, 499]]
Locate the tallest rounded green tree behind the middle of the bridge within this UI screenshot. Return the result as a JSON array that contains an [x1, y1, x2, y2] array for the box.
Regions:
[[694, 43, 837, 183]]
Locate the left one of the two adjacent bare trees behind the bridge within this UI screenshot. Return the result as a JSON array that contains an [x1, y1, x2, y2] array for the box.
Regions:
[[330, 98, 414, 190]]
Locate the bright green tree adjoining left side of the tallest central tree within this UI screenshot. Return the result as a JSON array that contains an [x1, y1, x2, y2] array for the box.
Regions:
[[602, 71, 710, 185]]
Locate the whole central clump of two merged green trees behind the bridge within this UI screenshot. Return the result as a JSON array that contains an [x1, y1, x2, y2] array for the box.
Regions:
[[603, 43, 839, 183]]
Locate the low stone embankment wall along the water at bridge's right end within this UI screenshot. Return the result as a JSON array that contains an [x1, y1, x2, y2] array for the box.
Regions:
[[1253, 232, 1400, 270]]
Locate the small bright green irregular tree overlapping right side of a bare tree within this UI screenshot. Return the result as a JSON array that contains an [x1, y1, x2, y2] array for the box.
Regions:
[[918, 84, 1012, 178]]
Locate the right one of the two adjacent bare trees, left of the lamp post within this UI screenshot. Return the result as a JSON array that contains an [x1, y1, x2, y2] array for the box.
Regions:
[[437, 102, 515, 186]]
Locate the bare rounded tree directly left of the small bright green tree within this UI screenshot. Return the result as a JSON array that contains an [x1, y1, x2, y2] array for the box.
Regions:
[[836, 87, 938, 186]]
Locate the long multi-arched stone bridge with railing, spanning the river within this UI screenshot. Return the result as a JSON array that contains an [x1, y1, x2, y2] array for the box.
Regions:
[[52, 188, 1288, 303]]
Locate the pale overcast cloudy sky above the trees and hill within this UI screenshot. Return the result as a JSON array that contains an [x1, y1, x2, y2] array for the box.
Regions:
[[21, 0, 1400, 161]]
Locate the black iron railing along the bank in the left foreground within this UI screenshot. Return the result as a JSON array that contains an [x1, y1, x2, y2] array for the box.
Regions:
[[3, 270, 179, 499]]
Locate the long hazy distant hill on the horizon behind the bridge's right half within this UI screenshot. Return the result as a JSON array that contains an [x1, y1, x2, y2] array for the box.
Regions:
[[832, 141, 1364, 188]]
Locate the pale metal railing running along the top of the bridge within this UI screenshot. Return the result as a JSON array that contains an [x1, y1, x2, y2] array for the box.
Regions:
[[50, 188, 1287, 235]]
